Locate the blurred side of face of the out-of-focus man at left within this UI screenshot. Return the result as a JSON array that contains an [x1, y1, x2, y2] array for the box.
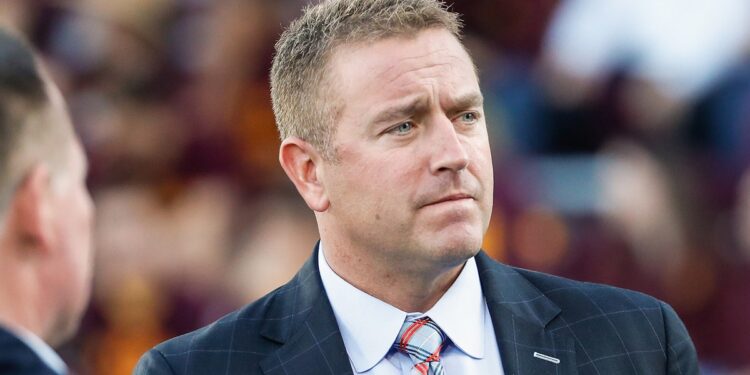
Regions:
[[49, 83, 93, 346]]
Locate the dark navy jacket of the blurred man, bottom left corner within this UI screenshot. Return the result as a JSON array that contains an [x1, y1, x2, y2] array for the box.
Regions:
[[0, 327, 57, 375]]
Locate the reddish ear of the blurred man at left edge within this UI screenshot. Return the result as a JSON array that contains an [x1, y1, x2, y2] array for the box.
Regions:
[[11, 164, 53, 251]]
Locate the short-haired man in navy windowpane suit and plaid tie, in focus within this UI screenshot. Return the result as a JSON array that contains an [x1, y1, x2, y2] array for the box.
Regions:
[[135, 0, 698, 375]]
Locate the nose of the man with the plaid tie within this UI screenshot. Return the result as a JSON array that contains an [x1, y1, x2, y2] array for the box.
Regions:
[[429, 116, 469, 174]]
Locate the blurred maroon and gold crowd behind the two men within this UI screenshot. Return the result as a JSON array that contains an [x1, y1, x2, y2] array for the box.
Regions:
[[0, 0, 750, 375]]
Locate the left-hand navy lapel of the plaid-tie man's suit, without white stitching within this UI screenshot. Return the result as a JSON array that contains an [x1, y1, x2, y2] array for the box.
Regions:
[[260, 246, 352, 375]]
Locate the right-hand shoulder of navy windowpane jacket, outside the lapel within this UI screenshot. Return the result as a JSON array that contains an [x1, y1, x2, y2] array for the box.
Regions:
[[515, 268, 699, 374]]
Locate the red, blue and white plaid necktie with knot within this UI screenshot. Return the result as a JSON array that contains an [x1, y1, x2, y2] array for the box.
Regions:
[[393, 317, 445, 375]]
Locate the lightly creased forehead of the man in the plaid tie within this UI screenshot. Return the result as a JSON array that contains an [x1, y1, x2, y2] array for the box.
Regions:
[[329, 29, 479, 103]]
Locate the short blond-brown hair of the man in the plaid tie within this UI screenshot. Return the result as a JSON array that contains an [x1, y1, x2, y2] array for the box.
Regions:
[[271, 0, 462, 160]]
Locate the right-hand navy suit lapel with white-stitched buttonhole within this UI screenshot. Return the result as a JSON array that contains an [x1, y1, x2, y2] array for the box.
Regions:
[[476, 252, 577, 375]]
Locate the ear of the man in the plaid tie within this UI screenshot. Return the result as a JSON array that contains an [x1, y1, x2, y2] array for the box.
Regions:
[[279, 137, 330, 212]]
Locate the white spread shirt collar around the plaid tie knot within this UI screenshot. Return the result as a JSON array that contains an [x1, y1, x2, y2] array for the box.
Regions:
[[318, 244, 486, 372]]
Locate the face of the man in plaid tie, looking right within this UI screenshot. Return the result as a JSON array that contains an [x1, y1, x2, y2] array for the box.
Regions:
[[319, 29, 493, 267]]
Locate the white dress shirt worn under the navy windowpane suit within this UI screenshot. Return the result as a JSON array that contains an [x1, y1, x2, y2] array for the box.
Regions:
[[318, 244, 503, 375]]
